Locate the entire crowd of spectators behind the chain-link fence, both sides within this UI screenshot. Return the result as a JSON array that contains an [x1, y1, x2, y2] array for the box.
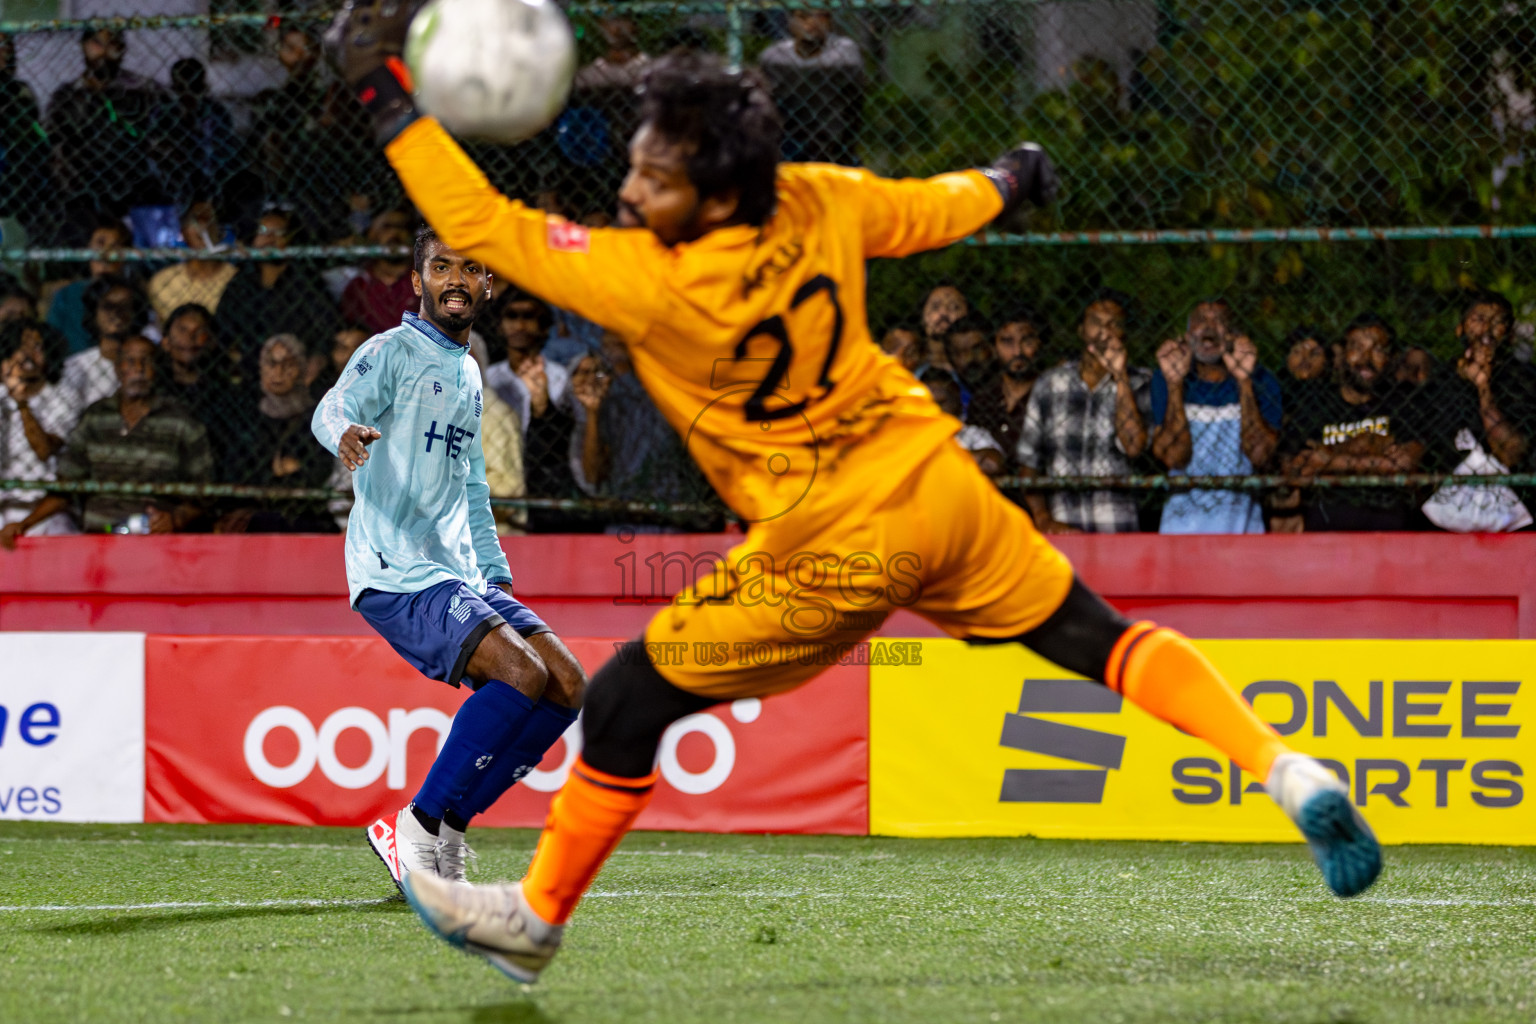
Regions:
[[0, 18, 1536, 547]]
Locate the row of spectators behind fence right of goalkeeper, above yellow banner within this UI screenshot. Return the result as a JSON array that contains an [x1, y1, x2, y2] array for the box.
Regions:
[[880, 282, 1536, 534]]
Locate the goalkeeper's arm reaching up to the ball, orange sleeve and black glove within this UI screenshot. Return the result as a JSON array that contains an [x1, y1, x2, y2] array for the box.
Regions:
[[326, 0, 665, 336]]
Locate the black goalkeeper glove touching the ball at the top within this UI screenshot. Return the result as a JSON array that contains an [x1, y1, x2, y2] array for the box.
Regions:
[[326, 0, 419, 146]]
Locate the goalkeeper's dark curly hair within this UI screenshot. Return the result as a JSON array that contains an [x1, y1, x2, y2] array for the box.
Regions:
[[641, 52, 783, 227]]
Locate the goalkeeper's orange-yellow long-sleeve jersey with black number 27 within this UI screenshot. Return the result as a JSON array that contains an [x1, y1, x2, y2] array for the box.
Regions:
[[386, 118, 1001, 537]]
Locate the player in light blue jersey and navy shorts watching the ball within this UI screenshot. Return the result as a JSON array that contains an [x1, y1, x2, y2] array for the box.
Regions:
[[312, 227, 587, 886]]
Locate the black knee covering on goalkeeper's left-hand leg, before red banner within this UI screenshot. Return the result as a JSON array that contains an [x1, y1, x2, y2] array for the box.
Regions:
[[582, 640, 719, 778]]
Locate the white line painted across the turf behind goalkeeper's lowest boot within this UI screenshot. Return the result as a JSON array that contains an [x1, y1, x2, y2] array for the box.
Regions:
[[0, 889, 1536, 913]]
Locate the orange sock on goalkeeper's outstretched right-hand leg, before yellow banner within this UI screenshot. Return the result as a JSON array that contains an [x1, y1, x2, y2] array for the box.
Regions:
[[1104, 622, 1290, 781]]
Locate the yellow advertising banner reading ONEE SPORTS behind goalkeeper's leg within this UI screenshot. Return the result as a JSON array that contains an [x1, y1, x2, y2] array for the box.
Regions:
[[869, 640, 1536, 844]]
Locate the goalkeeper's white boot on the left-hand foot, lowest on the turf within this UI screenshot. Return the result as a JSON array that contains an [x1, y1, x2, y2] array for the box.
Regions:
[[404, 872, 565, 984]]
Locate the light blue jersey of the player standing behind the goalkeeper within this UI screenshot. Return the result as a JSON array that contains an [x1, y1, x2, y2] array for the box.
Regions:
[[310, 313, 511, 606]]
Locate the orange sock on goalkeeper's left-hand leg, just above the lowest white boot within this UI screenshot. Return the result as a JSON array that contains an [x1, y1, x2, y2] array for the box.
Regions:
[[522, 758, 659, 924]]
